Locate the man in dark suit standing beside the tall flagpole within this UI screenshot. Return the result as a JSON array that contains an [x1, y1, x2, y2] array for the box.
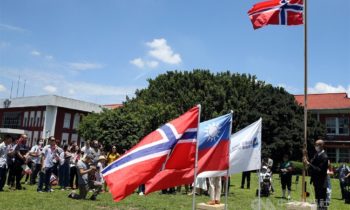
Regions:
[[303, 140, 328, 210]]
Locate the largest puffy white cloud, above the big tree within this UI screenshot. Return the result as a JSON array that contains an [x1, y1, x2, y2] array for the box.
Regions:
[[146, 38, 181, 64]]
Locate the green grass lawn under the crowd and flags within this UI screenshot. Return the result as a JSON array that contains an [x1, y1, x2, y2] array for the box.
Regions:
[[0, 173, 350, 210]]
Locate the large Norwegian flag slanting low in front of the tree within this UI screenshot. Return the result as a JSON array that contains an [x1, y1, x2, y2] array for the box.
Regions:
[[102, 107, 199, 201]]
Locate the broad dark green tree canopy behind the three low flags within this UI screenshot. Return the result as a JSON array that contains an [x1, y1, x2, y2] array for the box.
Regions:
[[79, 70, 324, 159]]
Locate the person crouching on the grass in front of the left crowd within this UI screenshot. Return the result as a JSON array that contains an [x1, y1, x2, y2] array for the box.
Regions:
[[68, 154, 101, 200]]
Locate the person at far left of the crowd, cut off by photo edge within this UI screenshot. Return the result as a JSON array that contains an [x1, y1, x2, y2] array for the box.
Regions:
[[0, 135, 12, 192]]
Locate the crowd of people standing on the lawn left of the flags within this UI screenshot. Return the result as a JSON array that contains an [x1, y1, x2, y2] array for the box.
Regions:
[[0, 135, 120, 200]]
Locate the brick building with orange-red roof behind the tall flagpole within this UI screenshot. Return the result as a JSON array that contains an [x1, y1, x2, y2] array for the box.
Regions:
[[295, 93, 350, 162]]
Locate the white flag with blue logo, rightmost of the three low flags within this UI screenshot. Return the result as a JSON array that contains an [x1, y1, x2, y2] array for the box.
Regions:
[[199, 118, 262, 177]]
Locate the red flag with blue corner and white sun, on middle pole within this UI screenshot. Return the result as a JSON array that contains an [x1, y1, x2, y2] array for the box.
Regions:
[[146, 114, 232, 194]]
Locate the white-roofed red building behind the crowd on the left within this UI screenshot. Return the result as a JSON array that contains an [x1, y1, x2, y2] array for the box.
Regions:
[[0, 95, 102, 146]]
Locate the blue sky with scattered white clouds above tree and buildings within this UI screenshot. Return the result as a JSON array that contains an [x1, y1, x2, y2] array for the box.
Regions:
[[0, 0, 350, 104]]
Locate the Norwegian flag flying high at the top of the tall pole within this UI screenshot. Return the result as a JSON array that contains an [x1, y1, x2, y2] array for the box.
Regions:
[[248, 0, 304, 29]]
